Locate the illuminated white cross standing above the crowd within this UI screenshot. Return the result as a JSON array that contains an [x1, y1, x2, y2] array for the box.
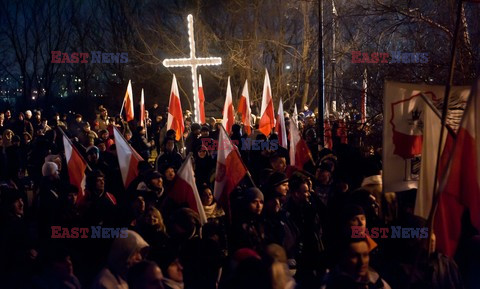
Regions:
[[163, 14, 222, 122]]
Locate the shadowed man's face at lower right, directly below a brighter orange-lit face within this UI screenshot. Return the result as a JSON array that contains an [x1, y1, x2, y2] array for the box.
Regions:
[[343, 241, 370, 279]]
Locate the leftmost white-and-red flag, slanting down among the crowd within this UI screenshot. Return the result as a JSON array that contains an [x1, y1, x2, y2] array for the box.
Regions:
[[63, 134, 87, 203]]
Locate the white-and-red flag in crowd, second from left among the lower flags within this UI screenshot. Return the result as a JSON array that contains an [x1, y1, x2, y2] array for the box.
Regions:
[[113, 127, 143, 188]]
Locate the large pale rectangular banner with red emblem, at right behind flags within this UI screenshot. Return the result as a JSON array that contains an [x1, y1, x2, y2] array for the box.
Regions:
[[383, 81, 470, 193]]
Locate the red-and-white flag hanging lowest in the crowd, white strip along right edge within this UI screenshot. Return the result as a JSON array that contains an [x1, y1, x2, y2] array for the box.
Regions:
[[169, 155, 207, 225]]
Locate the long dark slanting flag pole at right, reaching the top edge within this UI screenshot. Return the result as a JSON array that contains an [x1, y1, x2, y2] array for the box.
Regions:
[[428, 0, 463, 255]]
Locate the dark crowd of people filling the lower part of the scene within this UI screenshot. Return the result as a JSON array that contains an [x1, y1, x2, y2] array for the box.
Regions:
[[0, 106, 472, 289]]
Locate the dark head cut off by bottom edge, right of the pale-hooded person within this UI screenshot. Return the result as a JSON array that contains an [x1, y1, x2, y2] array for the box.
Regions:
[[127, 260, 164, 289]]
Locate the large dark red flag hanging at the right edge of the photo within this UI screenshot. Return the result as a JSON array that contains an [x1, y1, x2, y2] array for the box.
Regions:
[[434, 79, 480, 257]]
